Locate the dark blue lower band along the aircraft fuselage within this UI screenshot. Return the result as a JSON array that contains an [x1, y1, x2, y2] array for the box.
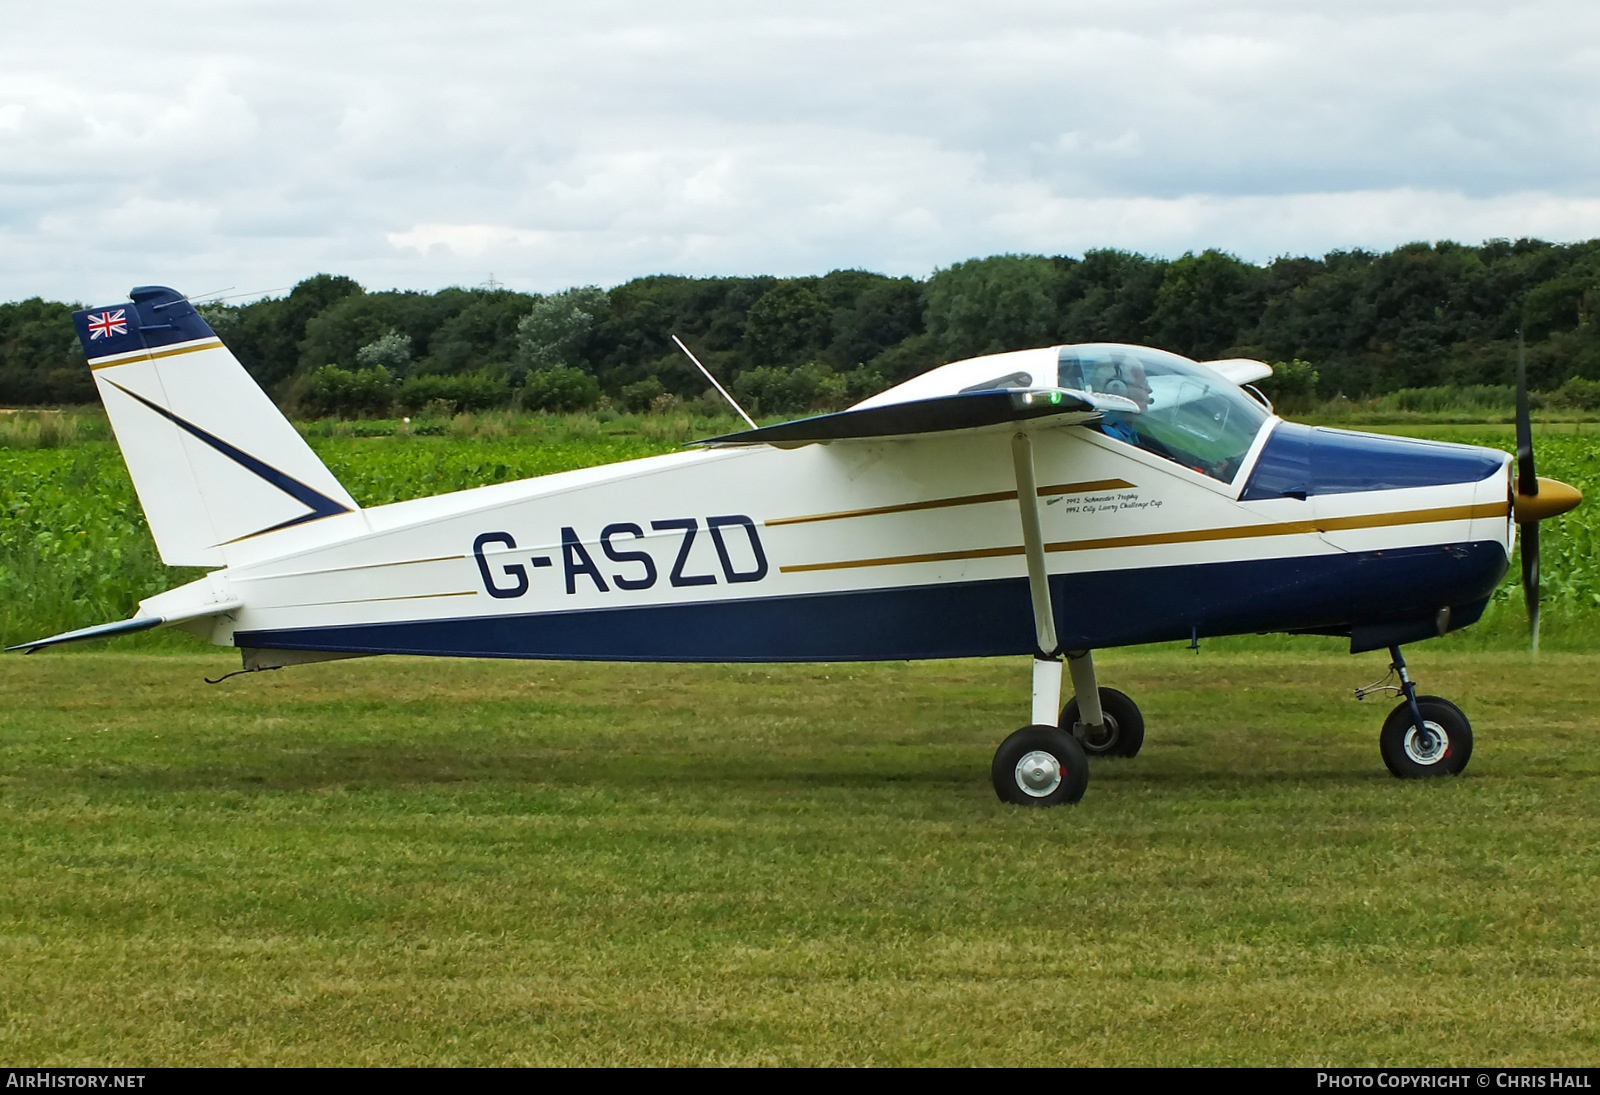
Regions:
[[234, 541, 1506, 661]]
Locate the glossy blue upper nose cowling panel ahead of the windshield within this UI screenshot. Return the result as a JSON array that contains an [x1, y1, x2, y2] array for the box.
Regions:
[[1240, 423, 1506, 501]]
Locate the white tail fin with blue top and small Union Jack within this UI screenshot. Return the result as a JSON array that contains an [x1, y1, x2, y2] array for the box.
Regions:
[[72, 285, 357, 567]]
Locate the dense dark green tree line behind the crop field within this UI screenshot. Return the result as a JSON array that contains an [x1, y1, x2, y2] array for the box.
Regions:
[[9, 240, 1600, 416]]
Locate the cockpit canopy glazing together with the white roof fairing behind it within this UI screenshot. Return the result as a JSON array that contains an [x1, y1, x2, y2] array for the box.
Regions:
[[856, 343, 1269, 483]]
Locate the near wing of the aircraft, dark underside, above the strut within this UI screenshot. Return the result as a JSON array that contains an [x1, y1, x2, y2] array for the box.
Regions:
[[696, 387, 1139, 447]]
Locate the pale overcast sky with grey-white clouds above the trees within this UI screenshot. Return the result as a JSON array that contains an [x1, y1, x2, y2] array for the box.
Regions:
[[0, 0, 1600, 303]]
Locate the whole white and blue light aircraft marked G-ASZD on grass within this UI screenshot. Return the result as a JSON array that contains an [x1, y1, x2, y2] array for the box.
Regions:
[[14, 287, 1581, 805]]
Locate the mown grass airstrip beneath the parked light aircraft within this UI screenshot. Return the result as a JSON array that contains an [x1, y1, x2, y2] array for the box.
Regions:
[[0, 640, 1600, 1065]]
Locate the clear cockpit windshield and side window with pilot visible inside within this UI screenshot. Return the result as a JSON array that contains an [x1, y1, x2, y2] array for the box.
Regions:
[[1058, 343, 1267, 483]]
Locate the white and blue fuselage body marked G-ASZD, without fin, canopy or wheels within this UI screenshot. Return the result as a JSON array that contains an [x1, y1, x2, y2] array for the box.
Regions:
[[150, 421, 1514, 664]]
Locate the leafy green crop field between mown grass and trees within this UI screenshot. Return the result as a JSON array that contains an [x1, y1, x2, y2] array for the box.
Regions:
[[0, 415, 1600, 650]]
